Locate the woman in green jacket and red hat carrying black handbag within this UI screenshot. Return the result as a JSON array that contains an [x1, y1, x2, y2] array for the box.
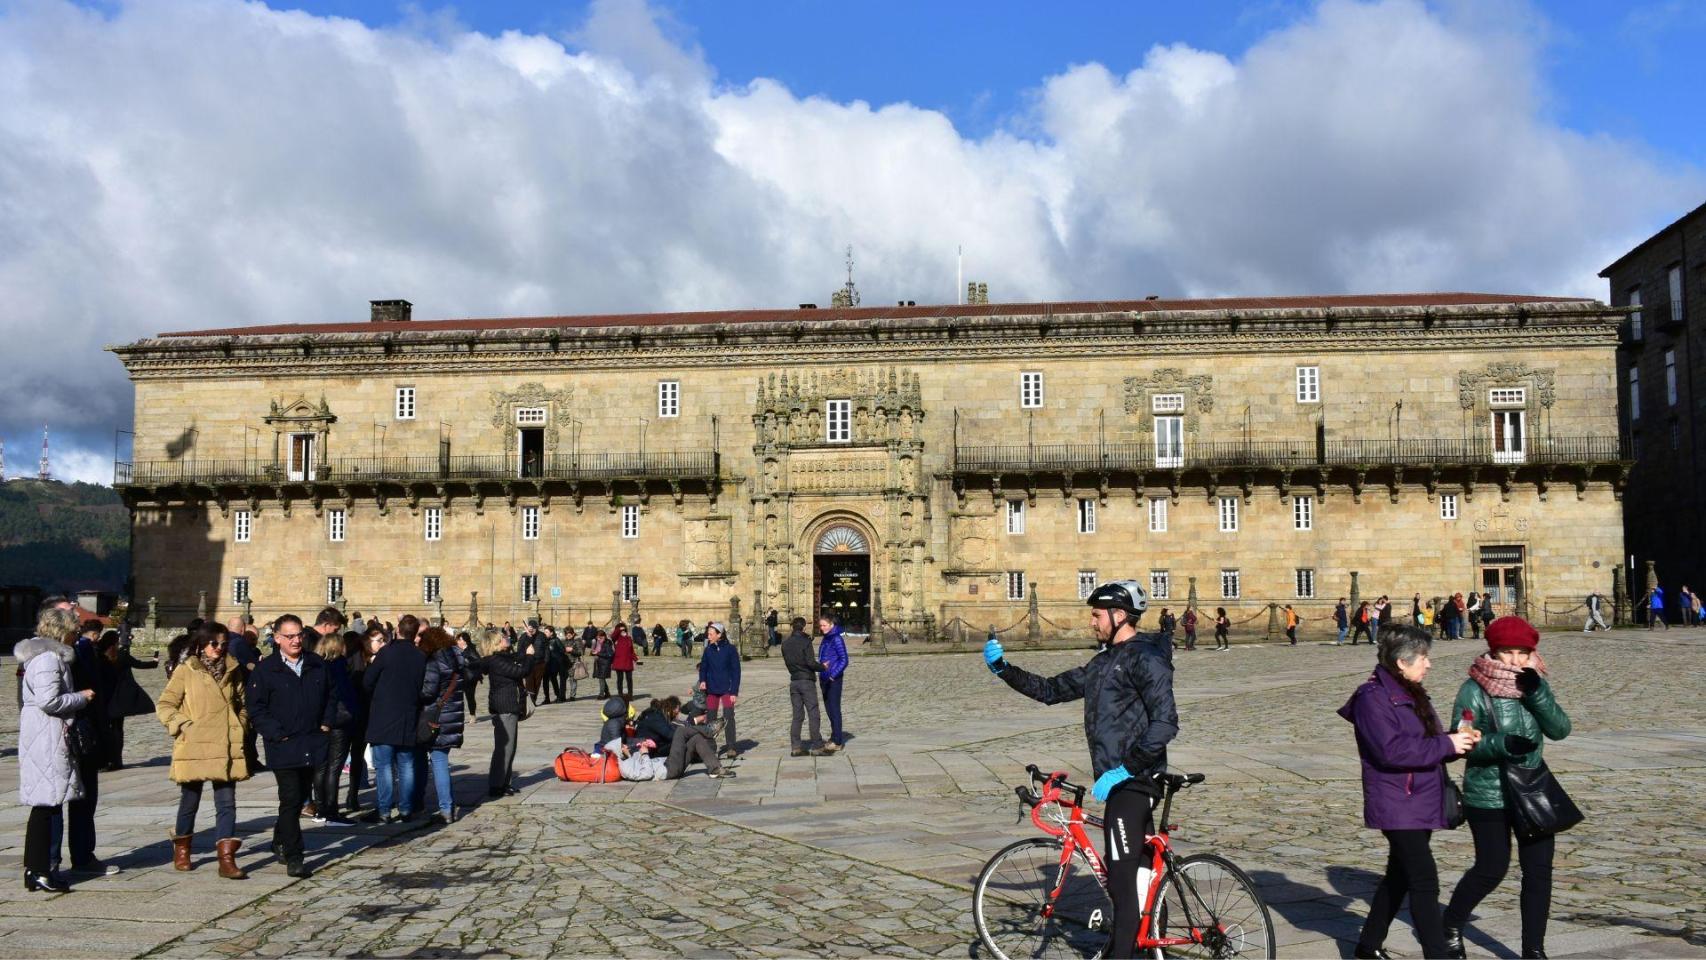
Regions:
[[1445, 617, 1570, 958]]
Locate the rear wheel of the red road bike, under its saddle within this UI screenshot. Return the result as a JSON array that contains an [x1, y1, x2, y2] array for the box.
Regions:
[[1150, 853, 1274, 958]]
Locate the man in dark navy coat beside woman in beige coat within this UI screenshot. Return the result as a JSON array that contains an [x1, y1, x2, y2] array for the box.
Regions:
[[247, 614, 336, 876]]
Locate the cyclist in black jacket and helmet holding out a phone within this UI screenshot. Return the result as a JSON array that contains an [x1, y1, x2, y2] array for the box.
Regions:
[[983, 580, 1179, 957]]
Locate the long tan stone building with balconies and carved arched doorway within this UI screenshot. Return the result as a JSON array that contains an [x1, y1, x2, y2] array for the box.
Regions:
[[111, 295, 1629, 643]]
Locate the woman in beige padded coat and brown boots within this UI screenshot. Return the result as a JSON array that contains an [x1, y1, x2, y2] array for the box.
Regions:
[[154, 622, 249, 880]]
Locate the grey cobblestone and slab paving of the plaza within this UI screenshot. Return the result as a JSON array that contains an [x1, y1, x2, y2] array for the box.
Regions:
[[0, 629, 1706, 957]]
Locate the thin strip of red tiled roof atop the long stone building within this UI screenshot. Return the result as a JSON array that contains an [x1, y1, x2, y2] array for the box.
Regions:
[[160, 293, 1593, 338]]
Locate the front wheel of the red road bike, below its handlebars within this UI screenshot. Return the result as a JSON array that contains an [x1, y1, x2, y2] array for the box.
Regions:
[[971, 837, 1114, 960]]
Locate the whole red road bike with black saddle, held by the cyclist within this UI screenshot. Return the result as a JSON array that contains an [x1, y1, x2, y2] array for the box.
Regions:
[[972, 764, 1274, 960]]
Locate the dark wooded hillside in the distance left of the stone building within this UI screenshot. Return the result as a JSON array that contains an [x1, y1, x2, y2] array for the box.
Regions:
[[0, 479, 130, 592]]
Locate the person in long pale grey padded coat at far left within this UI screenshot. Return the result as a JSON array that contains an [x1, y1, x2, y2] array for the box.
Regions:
[[12, 605, 96, 893]]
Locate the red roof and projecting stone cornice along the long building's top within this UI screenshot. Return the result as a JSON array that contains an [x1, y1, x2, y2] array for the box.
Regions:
[[107, 302, 1624, 380]]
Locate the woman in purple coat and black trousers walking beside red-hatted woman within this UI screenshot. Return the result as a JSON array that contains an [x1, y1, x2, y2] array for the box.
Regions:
[[1339, 626, 1481, 958]]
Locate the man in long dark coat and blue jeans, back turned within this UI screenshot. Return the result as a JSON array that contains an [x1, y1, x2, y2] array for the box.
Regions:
[[362, 614, 427, 824]]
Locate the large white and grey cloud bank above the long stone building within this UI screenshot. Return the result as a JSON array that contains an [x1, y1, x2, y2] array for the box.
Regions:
[[0, 0, 1706, 480]]
